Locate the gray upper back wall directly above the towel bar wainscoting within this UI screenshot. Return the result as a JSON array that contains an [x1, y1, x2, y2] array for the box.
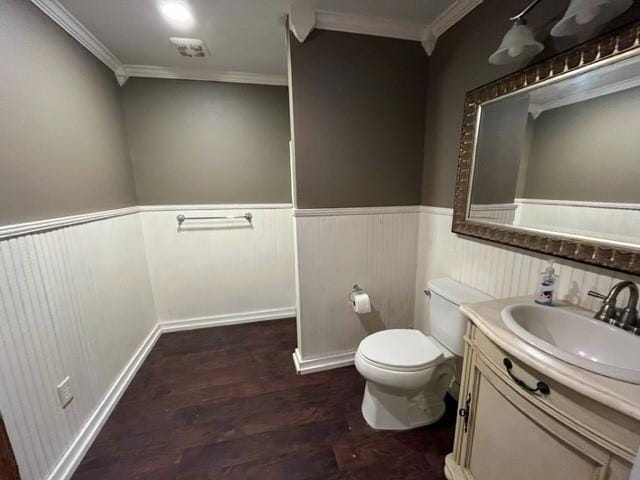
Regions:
[[124, 78, 291, 205]]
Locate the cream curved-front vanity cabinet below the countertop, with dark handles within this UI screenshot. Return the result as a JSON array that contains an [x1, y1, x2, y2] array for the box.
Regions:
[[445, 324, 640, 480]]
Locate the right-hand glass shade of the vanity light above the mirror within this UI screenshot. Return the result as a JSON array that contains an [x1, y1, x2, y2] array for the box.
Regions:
[[551, 0, 633, 37]]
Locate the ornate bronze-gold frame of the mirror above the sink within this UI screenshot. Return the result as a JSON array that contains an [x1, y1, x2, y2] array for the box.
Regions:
[[452, 22, 640, 274]]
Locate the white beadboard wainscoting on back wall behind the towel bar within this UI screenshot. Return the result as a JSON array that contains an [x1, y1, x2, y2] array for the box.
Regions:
[[140, 204, 295, 331]]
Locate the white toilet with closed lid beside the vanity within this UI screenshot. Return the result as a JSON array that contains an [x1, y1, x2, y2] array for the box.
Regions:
[[356, 278, 491, 430]]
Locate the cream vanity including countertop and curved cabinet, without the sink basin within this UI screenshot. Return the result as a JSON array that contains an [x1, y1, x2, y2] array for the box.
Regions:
[[445, 298, 640, 480]]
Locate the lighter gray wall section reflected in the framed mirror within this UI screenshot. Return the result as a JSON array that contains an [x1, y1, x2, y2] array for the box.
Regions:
[[524, 87, 640, 203]]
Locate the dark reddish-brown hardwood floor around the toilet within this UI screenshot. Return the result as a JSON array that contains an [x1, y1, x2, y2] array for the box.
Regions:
[[73, 319, 455, 480]]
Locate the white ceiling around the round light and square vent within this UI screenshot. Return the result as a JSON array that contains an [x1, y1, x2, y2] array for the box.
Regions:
[[42, 0, 470, 84]]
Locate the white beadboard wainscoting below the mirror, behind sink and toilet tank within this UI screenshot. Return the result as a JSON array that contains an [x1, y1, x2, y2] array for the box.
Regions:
[[414, 207, 640, 332]]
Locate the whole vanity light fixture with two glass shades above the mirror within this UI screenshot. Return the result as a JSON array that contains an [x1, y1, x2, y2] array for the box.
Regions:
[[489, 0, 633, 65]]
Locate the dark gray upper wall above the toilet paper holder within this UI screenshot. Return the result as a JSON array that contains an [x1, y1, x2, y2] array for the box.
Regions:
[[290, 30, 428, 208]]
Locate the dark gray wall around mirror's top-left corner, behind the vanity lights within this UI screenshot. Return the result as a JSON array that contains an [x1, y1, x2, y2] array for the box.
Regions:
[[422, 0, 640, 207]]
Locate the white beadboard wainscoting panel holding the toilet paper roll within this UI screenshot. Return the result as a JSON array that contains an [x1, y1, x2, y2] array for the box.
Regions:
[[294, 206, 418, 373]]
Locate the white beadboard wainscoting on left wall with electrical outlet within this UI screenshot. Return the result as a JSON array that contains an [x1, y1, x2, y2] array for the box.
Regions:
[[0, 212, 156, 480]]
